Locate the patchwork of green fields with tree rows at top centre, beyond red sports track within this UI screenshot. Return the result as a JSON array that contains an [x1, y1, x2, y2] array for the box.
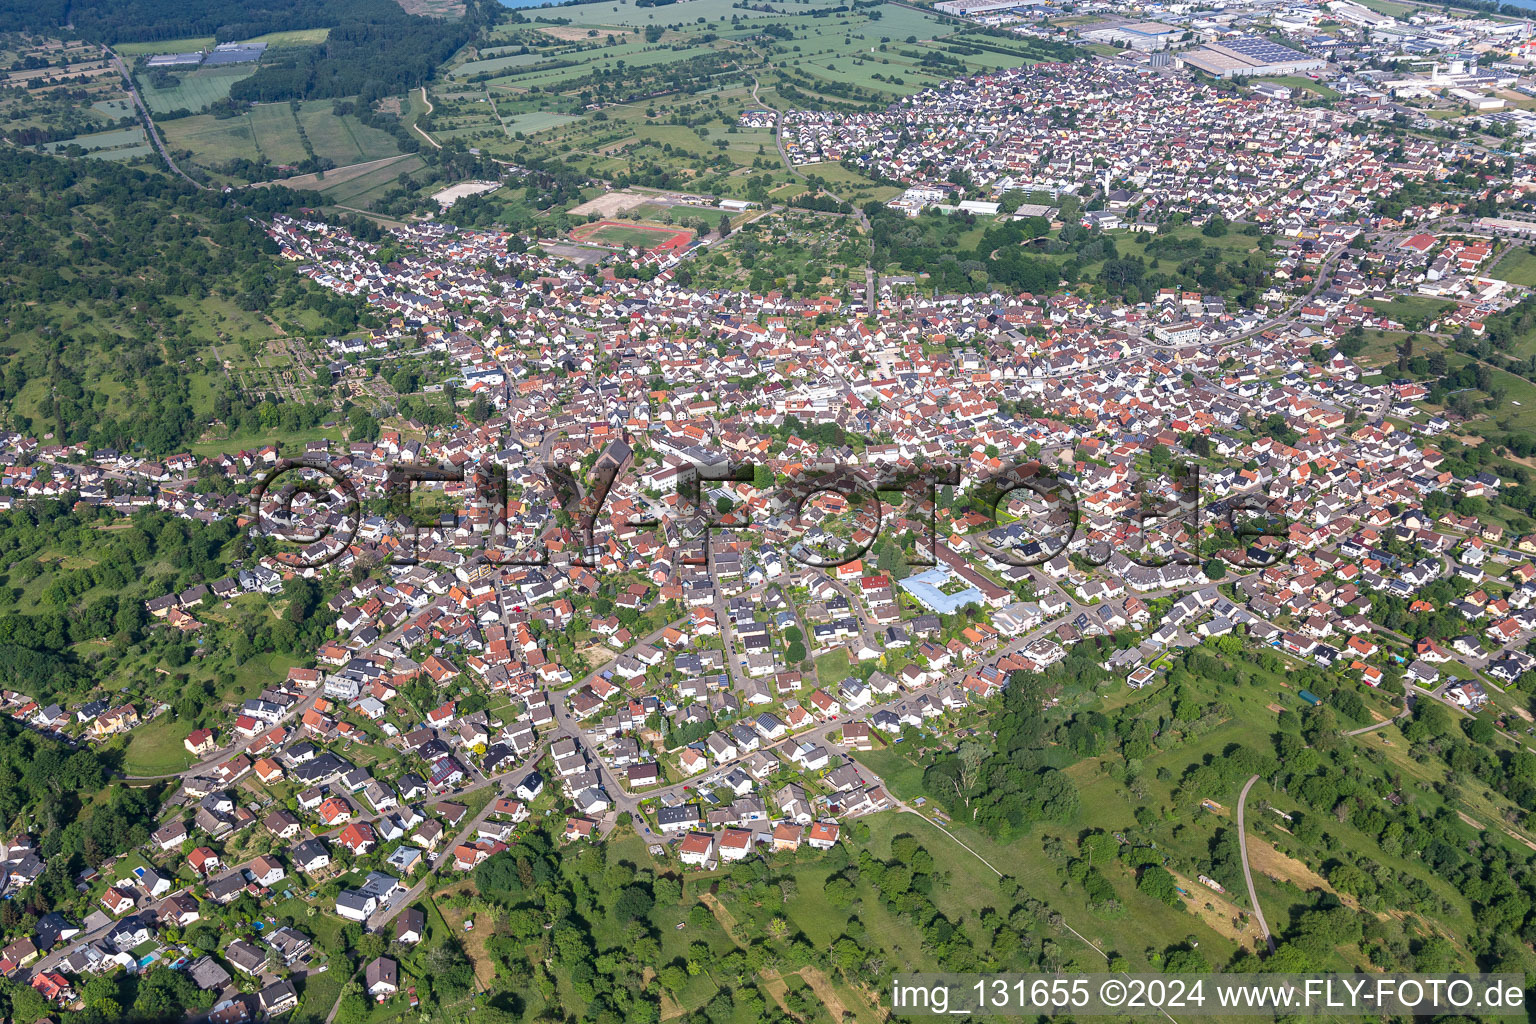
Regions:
[[430, 0, 1031, 201]]
